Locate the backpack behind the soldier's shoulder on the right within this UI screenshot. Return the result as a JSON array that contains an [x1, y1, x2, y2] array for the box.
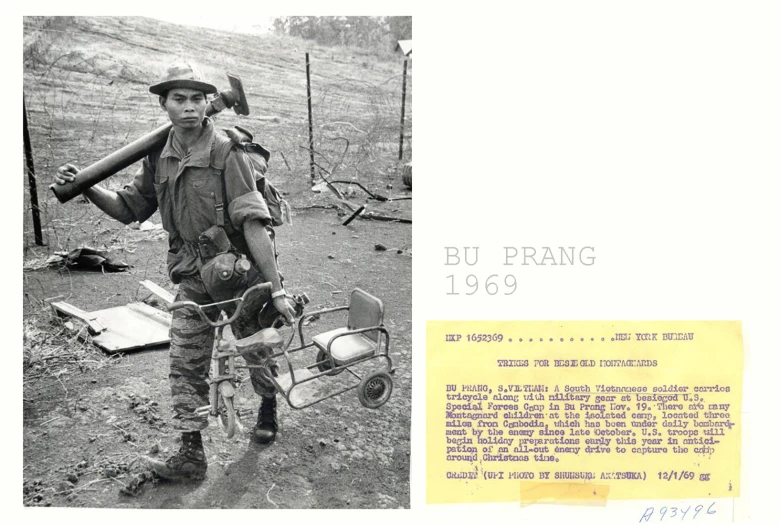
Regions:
[[211, 126, 292, 226]]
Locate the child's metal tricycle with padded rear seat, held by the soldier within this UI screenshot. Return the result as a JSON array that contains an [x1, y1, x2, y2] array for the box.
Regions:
[[168, 283, 395, 439]]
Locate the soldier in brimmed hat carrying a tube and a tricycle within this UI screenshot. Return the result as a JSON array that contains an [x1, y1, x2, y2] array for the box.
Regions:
[[55, 63, 294, 480]]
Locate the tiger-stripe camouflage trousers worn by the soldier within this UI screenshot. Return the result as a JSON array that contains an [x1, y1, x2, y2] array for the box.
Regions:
[[168, 276, 278, 432]]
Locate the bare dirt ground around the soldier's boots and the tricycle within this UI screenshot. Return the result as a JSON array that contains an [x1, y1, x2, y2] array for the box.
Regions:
[[23, 201, 412, 508]]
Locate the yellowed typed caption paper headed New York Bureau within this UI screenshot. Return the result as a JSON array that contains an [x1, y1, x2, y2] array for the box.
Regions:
[[426, 321, 743, 504]]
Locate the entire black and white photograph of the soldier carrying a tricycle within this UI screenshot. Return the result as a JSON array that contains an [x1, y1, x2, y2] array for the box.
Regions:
[[20, 14, 414, 509]]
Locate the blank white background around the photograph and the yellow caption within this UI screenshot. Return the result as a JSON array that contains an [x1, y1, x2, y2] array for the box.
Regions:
[[7, 1, 780, 523]]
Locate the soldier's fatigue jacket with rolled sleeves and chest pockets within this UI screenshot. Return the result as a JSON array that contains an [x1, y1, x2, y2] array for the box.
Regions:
[[117, 118, 271, 283]]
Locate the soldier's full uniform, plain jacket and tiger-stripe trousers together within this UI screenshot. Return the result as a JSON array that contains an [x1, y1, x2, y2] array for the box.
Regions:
[[117, 118, 276, 432]]
